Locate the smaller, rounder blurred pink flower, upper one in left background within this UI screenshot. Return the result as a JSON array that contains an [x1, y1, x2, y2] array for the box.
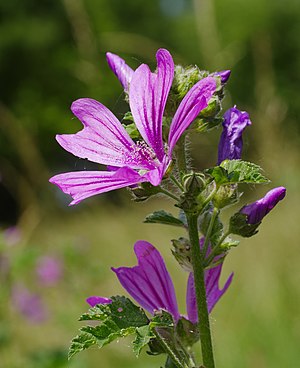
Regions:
[[36, 256, 63, 285]]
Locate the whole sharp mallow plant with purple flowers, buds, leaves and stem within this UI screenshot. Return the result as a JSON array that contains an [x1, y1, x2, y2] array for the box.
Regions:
[[49, 49, 286, 368]]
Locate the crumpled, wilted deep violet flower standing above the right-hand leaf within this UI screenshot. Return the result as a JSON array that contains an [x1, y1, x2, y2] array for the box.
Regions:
[[218, 106, 251, 164]]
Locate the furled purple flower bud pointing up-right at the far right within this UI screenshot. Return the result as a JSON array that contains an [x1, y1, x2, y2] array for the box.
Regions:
[[240, 187, 286, 224]]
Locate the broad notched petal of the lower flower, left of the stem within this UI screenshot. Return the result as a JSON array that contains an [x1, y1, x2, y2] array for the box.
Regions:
[[112, 240, 179, 320]]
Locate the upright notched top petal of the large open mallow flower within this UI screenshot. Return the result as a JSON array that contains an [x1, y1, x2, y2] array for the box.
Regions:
[[129, 49, 174, 161]]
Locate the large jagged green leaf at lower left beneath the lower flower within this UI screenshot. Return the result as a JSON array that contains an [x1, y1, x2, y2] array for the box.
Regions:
[[69, 296, 149, 358]]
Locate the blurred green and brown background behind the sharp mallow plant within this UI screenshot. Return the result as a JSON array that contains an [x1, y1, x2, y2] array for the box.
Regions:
[[0, 0, 300, 368]]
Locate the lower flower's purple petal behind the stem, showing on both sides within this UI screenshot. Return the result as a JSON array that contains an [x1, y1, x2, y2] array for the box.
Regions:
[[186, 264, 233, 323]]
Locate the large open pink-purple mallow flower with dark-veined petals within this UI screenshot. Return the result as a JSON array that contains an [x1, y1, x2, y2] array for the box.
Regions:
[[50, 49, 216, 205]]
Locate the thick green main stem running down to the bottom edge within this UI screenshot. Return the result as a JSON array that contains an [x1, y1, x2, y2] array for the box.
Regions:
[[186, 213, 215, 368]]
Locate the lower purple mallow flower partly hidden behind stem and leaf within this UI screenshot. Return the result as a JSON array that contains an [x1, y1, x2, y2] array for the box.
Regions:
[[87, 240, 233, 323]]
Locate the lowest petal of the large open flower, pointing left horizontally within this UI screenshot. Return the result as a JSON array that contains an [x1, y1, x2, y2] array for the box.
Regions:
[[49, 167, 146, 205]]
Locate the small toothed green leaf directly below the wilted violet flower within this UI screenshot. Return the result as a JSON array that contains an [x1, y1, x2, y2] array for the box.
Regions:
[[206, 160, 269, 185]]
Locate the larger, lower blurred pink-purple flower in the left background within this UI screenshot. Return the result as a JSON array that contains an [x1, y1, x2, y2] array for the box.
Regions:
[[11, 284, 47, 323]]
